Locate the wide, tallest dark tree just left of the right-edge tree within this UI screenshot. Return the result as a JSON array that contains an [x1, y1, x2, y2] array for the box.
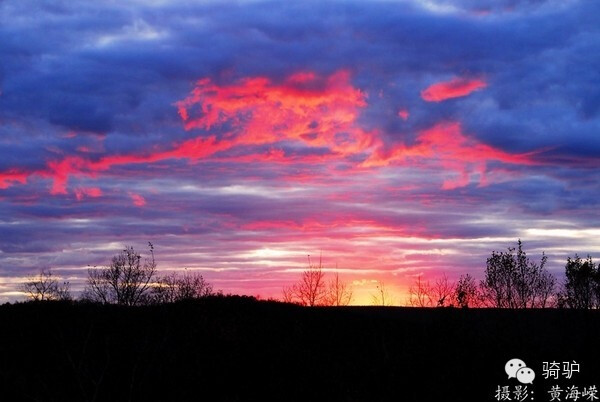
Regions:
[[481, 239, 556, 308]]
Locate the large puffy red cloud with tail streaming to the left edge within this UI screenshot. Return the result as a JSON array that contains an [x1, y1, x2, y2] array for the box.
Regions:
[[0, 71, 379, 194]]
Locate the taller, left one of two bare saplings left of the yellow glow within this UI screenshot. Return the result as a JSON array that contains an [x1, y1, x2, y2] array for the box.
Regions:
[[283, 255, 327, 306]]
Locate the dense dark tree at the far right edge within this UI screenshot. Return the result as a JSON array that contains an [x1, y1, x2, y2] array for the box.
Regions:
[[559, 254, 600, 309]]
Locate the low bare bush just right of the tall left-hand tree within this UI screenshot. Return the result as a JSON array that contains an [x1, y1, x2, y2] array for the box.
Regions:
[[152, 271, 213, 303]]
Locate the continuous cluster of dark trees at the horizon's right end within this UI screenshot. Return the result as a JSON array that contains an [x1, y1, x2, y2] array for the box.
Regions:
[[408, 239, 600, 309]]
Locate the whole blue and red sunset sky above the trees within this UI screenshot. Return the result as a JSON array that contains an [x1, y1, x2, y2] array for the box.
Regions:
[[0, 0, 600, 304]]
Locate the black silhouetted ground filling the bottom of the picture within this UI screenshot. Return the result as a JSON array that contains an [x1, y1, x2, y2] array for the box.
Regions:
[[0, 297, 600, 401]]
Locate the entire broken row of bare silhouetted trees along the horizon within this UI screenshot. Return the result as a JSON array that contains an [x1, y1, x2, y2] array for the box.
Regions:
[[23, 239, 600, 309]]
